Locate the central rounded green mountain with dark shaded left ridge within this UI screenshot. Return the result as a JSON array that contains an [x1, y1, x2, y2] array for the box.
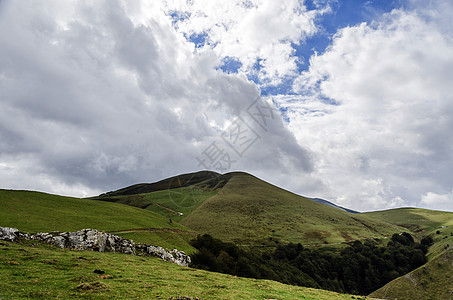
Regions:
[[94, 171, 403, 246]]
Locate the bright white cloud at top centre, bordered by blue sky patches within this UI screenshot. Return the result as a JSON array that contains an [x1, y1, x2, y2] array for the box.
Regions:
[[164, 0, 329, 85]]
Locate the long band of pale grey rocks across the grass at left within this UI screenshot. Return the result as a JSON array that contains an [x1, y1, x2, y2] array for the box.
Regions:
[[0, 227, 190, 267]]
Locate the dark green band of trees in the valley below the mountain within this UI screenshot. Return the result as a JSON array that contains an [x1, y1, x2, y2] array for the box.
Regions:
[[191, 233, 428, 295]]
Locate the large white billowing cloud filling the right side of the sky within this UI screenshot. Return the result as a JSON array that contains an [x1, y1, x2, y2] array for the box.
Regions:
[[279, 2, 453, 209]]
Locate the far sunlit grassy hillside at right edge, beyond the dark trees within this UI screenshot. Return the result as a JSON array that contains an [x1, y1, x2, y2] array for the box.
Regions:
[[365, 208, 453, 259]]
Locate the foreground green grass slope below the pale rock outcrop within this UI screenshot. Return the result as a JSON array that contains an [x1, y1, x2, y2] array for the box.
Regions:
[[0, 242, 360, 299]]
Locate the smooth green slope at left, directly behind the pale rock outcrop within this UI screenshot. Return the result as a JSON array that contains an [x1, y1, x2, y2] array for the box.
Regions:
[[0, 190, 194, 252]]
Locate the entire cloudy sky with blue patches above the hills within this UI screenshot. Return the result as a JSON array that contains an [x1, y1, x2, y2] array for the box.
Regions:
[[0, 0, 453, 211]]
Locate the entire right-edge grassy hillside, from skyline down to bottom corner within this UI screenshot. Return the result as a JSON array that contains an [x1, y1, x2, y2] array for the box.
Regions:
[[365, 208, 453, 299]]
